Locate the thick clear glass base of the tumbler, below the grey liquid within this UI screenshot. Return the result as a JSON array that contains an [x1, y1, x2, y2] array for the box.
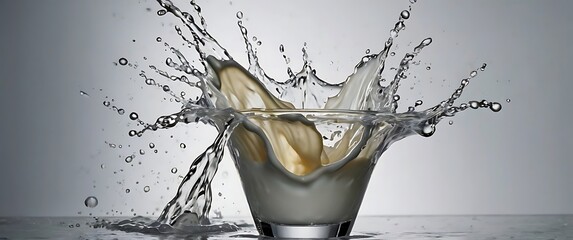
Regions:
[[254, 218, 354, 239]]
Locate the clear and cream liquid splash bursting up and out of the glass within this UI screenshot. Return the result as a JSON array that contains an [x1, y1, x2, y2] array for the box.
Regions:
[[109, 0, 501, 232]]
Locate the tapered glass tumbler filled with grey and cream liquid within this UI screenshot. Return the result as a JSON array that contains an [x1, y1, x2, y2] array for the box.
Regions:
[[228, 110, 387, 238]]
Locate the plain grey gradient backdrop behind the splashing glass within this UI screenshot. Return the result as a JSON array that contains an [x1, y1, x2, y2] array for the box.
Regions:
[[0, 0, 573, 216]]
